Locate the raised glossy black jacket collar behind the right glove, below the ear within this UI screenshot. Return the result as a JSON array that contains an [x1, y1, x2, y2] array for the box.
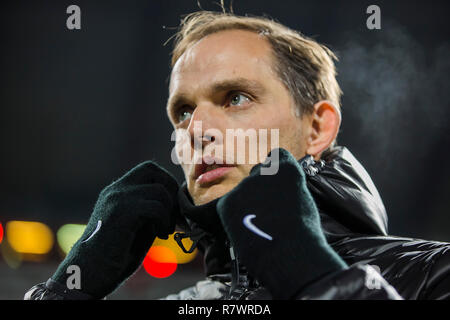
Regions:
[[307, 147, 388, 235]]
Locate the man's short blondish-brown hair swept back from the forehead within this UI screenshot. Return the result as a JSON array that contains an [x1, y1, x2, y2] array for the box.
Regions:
[[171, 11, 342, 116]]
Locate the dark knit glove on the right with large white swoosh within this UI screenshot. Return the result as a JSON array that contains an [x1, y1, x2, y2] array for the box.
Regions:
[[217, 149, 346, 299]]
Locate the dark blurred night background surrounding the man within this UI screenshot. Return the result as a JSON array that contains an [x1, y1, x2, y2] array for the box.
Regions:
[[0, 0, 450, 299]]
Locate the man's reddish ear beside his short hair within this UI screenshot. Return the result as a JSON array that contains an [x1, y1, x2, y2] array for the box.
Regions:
[[306, 100, 341, 159]]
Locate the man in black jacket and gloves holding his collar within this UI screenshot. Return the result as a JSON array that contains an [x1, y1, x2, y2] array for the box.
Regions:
[[25, 11, 450, 299]]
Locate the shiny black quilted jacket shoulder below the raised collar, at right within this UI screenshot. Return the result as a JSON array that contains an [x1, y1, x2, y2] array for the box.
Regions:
[[330, 235, 450, 300]]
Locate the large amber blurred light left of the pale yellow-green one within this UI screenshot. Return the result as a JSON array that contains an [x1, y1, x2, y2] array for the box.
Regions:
[[6, 221, 54, 254]]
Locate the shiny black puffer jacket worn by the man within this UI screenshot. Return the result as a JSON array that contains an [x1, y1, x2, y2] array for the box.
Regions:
[[160, 147, 450, 299]]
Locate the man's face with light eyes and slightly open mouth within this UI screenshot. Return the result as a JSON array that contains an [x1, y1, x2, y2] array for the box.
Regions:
[[167, 30, 310, 205]]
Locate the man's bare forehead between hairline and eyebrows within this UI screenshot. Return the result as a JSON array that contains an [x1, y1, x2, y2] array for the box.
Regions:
[[169, 30, 273, 93]]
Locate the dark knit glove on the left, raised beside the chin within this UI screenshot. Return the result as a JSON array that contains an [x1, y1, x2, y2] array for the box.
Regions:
[[47, 161, 178, 299]]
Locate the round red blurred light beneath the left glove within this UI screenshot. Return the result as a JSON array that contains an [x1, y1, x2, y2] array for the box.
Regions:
[[143, 246, 178, 278]]
